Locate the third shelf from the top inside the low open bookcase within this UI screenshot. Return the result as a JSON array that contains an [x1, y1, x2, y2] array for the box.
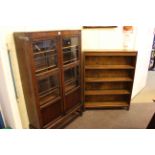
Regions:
[[85, 90, 130, 95]]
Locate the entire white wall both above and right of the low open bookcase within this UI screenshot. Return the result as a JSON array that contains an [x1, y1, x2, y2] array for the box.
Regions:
[[82, 26, 153, 98]]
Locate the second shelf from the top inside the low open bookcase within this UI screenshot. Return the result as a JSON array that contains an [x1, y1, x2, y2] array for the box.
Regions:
[[85, 77, 133, 82]]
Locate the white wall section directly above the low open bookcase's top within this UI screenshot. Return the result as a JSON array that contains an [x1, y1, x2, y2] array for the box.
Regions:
[[82, 27, 123, 50]]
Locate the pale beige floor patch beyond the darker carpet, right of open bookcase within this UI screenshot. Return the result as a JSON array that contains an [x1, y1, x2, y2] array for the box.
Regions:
[[131, 71, 155, 103]]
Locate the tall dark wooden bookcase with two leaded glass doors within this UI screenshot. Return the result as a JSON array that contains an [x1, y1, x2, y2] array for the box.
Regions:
[[14, 30, 83, 128]]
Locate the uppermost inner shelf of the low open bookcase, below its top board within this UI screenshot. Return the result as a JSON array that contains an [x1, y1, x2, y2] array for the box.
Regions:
[[85, 65, 134, 69]]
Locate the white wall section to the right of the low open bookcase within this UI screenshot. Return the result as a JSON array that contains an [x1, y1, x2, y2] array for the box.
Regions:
[[132, 26, 154, 97]]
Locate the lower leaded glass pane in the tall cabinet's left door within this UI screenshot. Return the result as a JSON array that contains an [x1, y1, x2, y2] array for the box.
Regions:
[[38, 74, 60, 104]]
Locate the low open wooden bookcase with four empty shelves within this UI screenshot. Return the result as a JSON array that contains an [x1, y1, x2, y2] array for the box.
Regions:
[[84, 51, 137, 109]]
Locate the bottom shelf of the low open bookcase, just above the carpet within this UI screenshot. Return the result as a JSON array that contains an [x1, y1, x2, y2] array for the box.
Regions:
[[85, 101, 129, 108]]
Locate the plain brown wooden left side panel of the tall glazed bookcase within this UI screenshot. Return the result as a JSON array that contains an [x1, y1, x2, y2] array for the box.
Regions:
[[14, 33, 41, 128]]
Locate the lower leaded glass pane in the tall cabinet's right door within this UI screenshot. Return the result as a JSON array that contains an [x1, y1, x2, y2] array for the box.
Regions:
[[64, 66, 79, 92]]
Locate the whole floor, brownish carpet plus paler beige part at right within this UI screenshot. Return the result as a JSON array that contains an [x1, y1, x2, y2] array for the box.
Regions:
[[66, 71, 155, 129]]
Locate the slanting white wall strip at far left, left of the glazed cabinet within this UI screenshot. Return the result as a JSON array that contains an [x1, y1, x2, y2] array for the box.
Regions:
[[0, 31, 22, 128]]
